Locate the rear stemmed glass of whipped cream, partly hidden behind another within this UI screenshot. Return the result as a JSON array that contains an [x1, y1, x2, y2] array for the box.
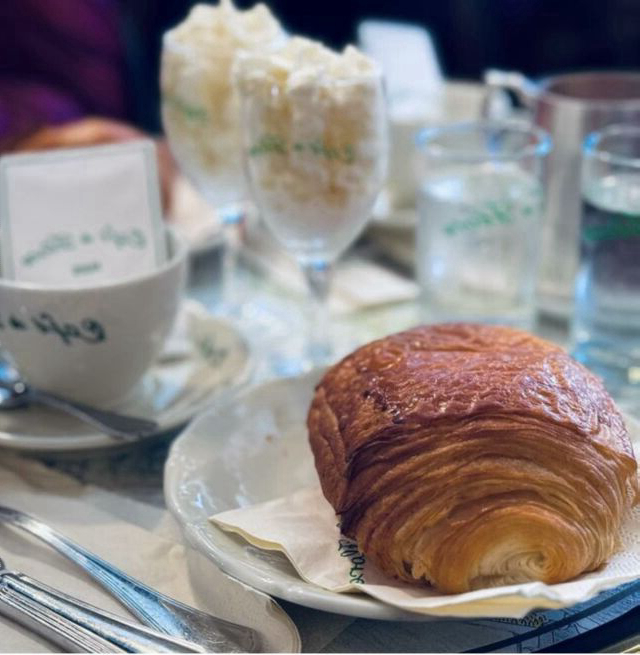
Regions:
[[160, 0, 284, 309]]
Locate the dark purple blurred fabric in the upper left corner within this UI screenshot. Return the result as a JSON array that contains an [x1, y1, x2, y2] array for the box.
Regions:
[[0, 0, 127, 145]]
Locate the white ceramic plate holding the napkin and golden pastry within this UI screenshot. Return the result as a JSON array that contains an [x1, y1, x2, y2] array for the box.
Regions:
[[164, 372, 430, 621]]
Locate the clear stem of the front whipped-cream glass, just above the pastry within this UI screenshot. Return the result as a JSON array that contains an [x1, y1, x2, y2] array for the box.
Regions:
[[302, 261, 333, 366]]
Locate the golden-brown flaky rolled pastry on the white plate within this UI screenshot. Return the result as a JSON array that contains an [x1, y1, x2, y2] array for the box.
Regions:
[[307, 323, 638, 593]]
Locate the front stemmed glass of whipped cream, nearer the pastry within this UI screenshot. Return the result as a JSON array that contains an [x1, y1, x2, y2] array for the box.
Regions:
[[234, 37, 387, 365]]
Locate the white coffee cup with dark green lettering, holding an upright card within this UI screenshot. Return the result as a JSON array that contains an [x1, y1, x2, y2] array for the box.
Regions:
[[0, 228, 187, 406]]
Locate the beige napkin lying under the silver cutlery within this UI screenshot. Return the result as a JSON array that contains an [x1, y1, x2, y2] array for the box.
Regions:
[[0, 455, 300, 653]]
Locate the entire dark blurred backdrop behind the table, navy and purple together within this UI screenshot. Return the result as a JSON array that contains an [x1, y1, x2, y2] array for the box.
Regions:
[[0, 0, 640, 146]]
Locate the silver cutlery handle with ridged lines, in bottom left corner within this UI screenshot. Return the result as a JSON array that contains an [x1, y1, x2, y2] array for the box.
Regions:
[[0, 559, 204, 653]]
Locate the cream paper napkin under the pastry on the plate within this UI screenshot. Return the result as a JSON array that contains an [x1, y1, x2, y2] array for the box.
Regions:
[[211, 418, 640, 618]]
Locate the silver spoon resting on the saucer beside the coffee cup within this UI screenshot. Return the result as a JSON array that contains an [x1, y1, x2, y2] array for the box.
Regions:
[[0, 362, 159, 439]]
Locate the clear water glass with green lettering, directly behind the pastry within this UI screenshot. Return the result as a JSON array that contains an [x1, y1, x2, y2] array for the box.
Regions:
[[417, 121, 551, 329]]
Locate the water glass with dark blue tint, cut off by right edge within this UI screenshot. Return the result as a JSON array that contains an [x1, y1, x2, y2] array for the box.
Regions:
[[573, 125, 640, 411]]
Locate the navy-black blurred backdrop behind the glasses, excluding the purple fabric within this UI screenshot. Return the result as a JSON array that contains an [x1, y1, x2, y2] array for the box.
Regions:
[[125, 0, 640, 127]]
